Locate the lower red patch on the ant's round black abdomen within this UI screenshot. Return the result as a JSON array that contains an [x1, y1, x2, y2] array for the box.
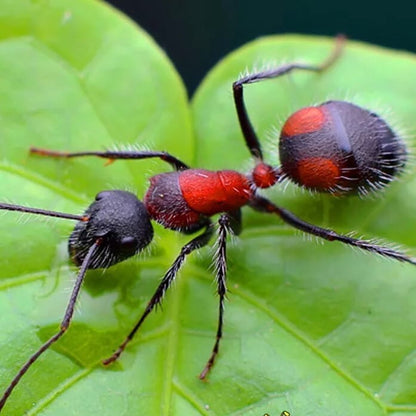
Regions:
[[297, 157, 340, 191]]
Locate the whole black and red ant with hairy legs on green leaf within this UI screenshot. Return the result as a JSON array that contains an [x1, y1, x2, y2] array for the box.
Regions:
[[0, 36, 416, 411]]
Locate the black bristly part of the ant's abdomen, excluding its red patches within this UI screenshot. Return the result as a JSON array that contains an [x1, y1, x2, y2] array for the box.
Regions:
[[279, 101, 407, 194]]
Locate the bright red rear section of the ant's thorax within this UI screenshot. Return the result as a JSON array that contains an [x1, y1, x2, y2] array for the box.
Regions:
[[179, 169, 252, 215]]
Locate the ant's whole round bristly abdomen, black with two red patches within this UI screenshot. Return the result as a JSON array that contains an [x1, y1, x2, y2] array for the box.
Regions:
[[279, 101, 407, 194]]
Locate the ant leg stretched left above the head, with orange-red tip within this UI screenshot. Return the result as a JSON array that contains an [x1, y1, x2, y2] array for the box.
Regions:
[[30, 147, 189, 170]]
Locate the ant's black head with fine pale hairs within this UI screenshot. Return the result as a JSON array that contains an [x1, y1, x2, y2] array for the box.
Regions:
[[68, 190, 153, 269]]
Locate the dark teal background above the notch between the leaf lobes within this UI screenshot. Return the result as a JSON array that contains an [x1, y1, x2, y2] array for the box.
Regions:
[[106, 0, 416, 94]]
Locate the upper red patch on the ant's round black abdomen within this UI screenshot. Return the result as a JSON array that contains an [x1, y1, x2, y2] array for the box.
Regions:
[[282, 107, 326, 137]]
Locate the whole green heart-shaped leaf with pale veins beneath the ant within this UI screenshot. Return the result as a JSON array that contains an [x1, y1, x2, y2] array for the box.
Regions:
[[0, 0, 416, 416]]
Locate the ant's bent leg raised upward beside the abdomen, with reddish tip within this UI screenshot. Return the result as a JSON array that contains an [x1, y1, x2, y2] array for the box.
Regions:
[[233, 35, 345, 160]]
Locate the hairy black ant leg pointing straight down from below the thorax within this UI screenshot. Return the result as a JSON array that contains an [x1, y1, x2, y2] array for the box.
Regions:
[[199, 210, 234, 380]]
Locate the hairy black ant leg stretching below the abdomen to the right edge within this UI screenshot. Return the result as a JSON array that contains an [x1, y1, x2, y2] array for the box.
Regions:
[[250, 196, 416, 265]]
